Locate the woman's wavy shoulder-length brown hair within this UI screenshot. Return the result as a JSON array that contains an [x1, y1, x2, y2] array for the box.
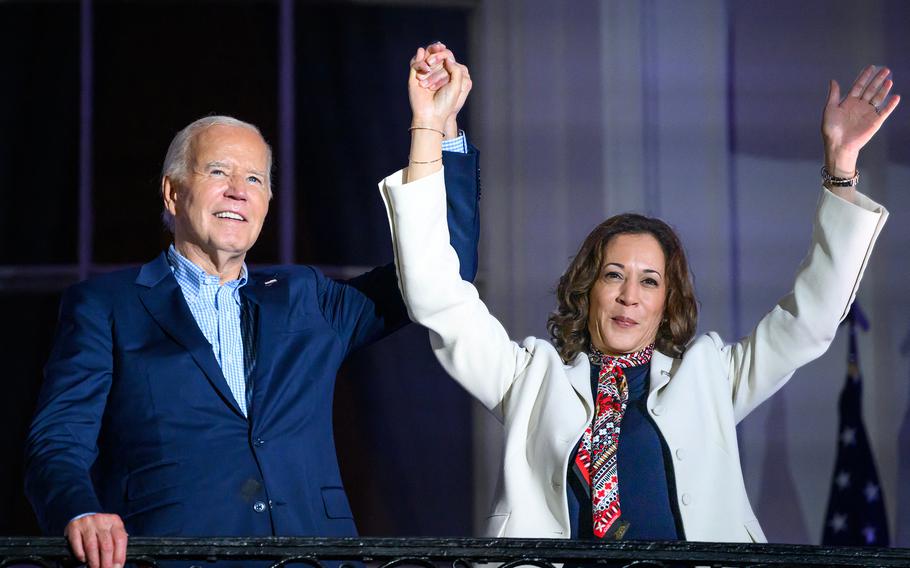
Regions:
[[547, 213, 698, 363]]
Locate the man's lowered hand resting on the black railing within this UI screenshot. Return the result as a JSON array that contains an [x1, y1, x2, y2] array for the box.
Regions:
[[64, 513, 129, 568]]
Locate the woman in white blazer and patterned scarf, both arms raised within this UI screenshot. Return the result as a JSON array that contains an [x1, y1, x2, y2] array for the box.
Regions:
[[381, 60, 898, 542]]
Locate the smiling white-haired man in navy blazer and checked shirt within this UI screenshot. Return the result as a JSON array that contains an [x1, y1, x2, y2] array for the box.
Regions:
[[26, 44, 479, 568]]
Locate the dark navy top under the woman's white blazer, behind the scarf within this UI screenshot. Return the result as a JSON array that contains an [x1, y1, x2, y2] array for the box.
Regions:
[[566, 364, 685, 540]]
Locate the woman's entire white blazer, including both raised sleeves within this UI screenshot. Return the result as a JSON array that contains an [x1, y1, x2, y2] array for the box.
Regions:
[[380, 172, 888, 542]]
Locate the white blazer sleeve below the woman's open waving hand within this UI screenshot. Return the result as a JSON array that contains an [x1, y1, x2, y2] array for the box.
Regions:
[[712, 188, 888, 422]]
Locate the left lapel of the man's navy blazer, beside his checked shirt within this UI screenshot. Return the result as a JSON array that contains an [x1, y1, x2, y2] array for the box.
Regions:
[[136, 253, 244, 418]]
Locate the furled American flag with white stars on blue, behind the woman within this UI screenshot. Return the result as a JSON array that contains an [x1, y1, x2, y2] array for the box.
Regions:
[[822, 303, 889, 546]]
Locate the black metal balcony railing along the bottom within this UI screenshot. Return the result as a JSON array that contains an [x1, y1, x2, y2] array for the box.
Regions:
[[0, 537, 910, 568]]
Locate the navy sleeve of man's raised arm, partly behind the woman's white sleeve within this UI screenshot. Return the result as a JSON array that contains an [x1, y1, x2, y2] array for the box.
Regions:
[[319, 146, 488, 352]]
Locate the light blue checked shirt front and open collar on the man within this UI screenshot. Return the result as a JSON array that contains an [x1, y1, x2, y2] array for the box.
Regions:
[[167, 245, 249, 416]]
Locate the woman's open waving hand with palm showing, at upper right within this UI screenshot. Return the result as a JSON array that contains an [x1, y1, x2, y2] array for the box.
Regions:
[[822, 65, 900, 178]]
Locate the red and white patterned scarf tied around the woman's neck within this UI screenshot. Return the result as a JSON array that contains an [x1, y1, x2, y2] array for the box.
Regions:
[[575, 344, 654, 538]]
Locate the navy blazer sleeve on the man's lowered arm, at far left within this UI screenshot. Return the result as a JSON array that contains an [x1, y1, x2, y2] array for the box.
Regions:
[[25, 283, 113, 535]]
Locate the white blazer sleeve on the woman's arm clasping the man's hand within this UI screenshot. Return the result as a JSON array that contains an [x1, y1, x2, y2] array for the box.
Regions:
[[379, 166, 531, 415]]
